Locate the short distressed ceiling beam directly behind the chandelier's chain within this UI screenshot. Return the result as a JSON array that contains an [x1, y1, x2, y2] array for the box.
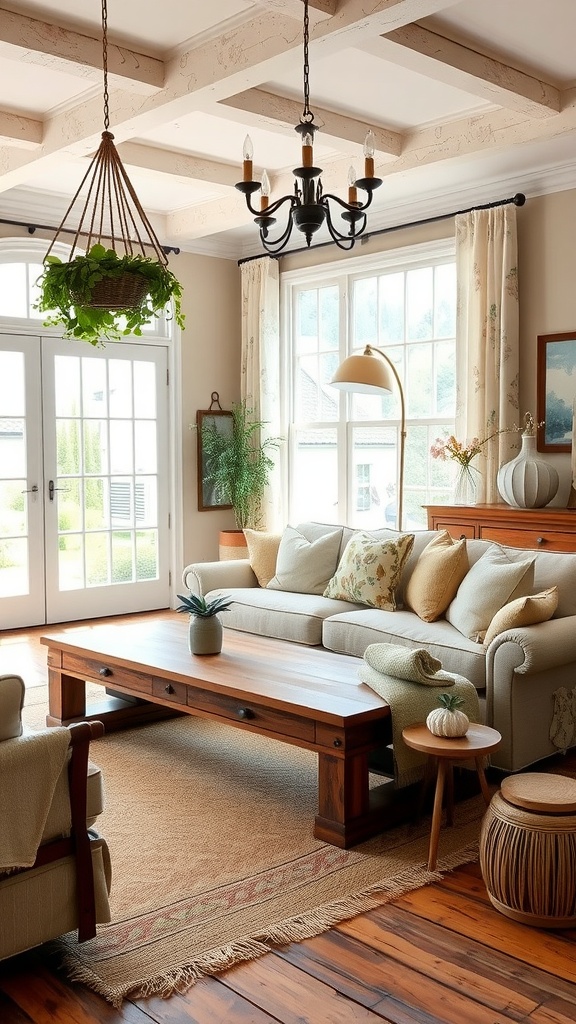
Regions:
[[219, 89, 402, 157]]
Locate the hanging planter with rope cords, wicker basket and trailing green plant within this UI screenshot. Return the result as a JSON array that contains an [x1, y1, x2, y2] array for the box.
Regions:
[[37, 0, 183, 345]]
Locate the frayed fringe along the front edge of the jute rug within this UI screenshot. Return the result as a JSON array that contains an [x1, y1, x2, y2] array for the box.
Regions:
[[53, 843, 479, 1009]]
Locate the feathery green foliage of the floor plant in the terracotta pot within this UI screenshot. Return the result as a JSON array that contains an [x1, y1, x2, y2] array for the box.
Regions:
[[202, 399, 284, 529]]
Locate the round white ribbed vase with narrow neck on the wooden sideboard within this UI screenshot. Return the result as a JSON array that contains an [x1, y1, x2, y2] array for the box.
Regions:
[[496, 434, 560, 509]]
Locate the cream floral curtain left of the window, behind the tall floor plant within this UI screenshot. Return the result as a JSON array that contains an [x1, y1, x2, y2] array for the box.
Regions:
[[241, 256, 284, 530]]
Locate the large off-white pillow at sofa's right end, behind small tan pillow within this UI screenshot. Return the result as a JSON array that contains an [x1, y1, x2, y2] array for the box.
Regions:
[[446, 544, 536, 643]]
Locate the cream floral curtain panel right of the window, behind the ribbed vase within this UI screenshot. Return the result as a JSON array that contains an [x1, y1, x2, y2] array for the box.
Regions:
[[456, 204, 520, 502]]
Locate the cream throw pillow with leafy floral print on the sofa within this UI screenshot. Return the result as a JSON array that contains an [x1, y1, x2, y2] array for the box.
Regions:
[[324, 531, 414, 611]]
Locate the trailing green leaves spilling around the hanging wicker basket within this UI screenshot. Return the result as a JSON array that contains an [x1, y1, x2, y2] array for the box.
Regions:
[[35, 244, 184, 345]]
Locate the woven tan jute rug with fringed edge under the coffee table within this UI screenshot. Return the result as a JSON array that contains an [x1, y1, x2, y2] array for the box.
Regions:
[[25, 688, 485, 1007]]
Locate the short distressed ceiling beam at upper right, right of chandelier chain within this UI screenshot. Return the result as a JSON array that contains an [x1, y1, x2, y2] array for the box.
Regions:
[[379, 25, 560, 118]]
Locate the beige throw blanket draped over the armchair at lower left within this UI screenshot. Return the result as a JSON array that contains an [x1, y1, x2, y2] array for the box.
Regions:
[[0, 727, 70, 871]]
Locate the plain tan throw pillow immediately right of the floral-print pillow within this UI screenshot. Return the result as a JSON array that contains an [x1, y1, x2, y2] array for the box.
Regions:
[[404, 529, 469, 623]]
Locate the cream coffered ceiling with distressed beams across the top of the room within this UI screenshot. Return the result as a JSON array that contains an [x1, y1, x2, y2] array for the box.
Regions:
[[0, 0, 576, 258]]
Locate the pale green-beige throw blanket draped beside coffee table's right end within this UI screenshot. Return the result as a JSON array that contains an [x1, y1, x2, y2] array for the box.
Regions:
[[358, 644, 481, 788]]
